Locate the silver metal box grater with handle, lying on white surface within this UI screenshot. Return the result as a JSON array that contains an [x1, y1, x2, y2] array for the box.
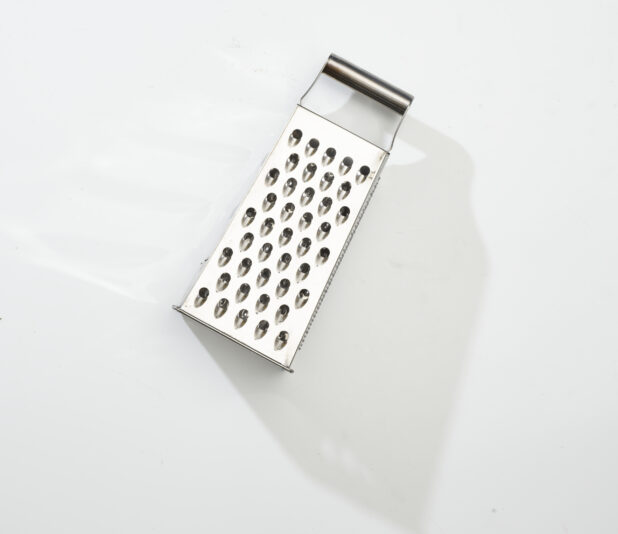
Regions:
[[175, 55, 412, 371]]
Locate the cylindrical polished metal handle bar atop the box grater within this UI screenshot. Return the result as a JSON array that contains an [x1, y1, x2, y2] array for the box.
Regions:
[[322, 54, 413, 115]]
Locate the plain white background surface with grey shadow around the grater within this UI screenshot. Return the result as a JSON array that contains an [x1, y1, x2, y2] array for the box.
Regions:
[[0, 0, 618, 534]]
